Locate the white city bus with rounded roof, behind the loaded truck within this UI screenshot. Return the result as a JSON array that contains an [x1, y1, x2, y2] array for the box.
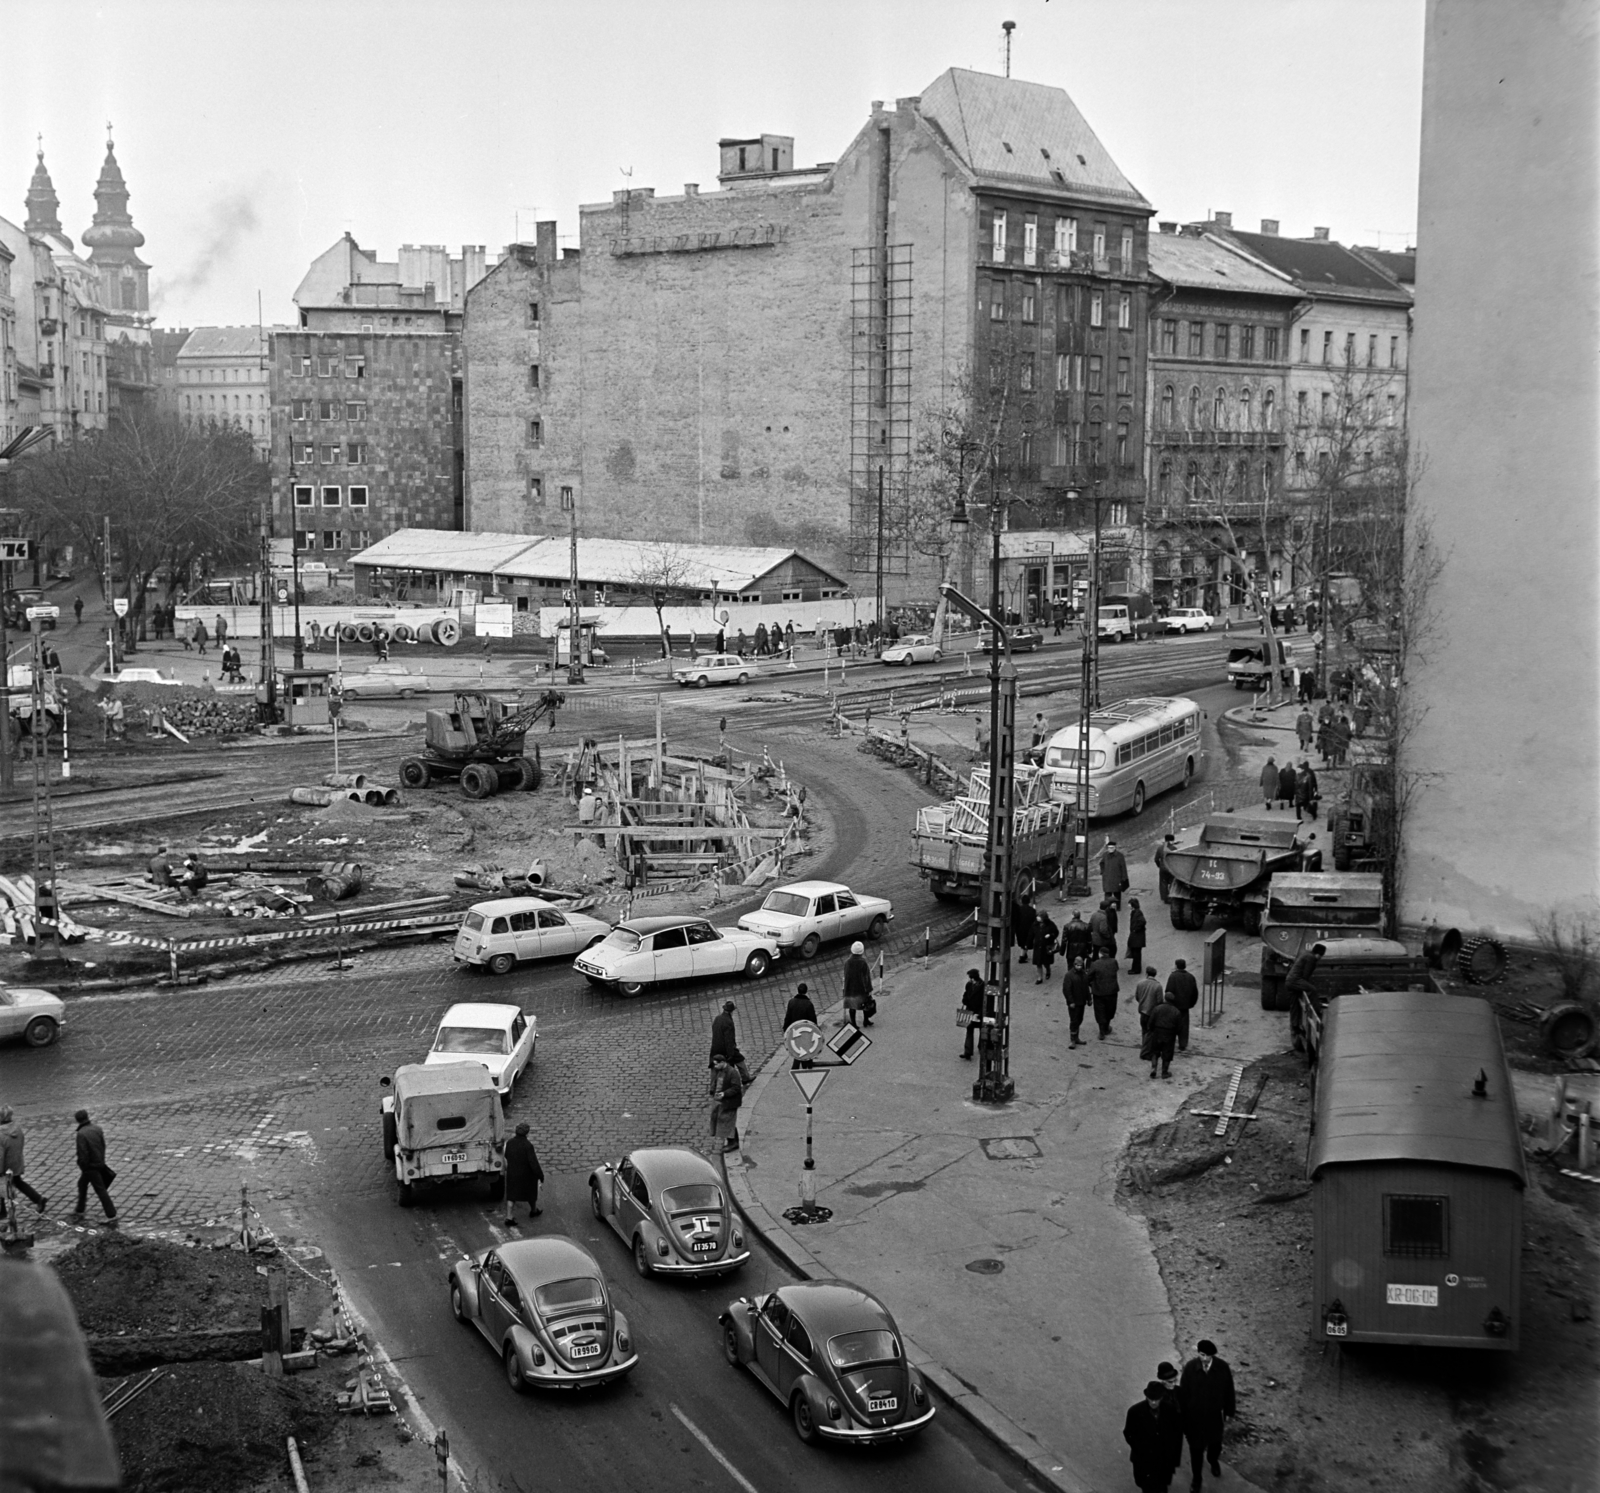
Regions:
[[1045, 694, 1205, 819]]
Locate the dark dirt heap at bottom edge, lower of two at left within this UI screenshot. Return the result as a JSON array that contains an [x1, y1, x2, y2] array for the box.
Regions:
[[104, 1363, 339, 1493]]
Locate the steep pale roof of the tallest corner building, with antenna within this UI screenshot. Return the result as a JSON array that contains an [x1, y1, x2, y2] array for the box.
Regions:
[[918, 67, 1150, 210]]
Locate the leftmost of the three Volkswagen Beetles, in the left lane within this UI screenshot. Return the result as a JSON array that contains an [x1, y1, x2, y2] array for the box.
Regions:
[[450, 1234, 638, 1392]]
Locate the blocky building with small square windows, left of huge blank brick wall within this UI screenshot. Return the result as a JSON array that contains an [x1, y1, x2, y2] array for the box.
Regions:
[[269, 234, 485, 565]]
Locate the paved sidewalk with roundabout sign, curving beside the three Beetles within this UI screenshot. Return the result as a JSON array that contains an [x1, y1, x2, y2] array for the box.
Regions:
[[728, 896, 1285, 1493]]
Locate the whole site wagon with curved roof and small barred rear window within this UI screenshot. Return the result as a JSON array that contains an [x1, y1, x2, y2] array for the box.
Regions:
[[1307, 991, 1528, 1351]]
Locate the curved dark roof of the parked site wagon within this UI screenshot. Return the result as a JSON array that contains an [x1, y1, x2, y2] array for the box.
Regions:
[[1307, 991, 1528, 1183]]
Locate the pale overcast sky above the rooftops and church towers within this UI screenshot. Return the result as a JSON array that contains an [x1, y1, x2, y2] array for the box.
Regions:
[[0, 0, 1424, 326]]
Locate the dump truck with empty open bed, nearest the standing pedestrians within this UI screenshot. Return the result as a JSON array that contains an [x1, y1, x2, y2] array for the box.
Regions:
[[1162, 810, 1322, 935]]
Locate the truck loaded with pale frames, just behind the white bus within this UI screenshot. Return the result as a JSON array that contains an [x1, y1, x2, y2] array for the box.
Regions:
[[910, 765, 1077, 903]]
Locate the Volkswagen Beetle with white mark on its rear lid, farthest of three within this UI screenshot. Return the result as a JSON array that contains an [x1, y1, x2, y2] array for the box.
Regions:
[[589, 1146, 750, 1277]]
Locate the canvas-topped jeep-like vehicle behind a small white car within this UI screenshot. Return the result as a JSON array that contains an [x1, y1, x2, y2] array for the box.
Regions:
[[379, 1061, 506, 1208]]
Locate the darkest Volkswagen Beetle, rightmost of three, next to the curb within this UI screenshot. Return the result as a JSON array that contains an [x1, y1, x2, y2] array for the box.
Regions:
[[720, 1280, 933, 1443]]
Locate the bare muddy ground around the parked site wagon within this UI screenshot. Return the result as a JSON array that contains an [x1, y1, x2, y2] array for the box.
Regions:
[[1118, 1049, 1600, 1493]]
